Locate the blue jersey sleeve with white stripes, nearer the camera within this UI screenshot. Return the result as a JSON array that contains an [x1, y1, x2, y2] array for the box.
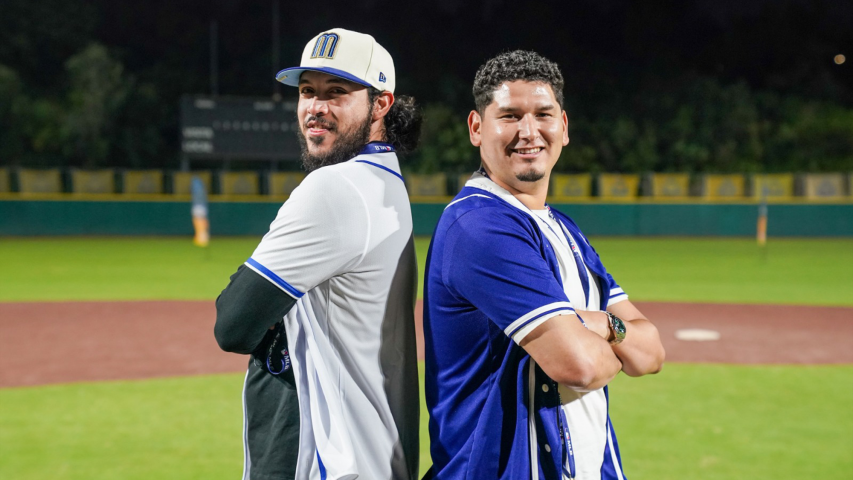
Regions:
[[442, 208, 574, 342]]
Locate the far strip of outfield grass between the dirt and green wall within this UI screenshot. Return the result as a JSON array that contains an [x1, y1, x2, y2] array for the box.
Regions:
[[0, 237, 853, 305]]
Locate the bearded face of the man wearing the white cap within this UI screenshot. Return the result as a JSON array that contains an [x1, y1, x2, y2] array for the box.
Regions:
[[296, 71, 373, 172]]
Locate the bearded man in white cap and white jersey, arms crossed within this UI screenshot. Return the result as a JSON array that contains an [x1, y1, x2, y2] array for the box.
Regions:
[[214, 28, 422, 480]]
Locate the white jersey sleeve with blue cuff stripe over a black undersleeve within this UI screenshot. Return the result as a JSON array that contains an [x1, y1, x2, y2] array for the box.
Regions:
[[246, 168, 369, 299]]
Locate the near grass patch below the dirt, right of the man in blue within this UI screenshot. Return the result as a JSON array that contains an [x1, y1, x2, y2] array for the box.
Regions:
[[611, 364, 853, 480]]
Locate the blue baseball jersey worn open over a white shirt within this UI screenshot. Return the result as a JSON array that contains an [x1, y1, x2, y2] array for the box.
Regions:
[[424, 183, 624, 480]]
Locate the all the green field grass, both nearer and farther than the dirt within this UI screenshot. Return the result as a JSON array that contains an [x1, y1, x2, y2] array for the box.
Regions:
[[0, 238, 853, 480]]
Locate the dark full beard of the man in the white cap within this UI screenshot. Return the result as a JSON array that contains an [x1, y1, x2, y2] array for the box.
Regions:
[[297, 112, 371, 173]]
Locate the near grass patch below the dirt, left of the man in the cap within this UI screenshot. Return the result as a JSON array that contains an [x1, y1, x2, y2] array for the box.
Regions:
[[0, 374, 243, 480]]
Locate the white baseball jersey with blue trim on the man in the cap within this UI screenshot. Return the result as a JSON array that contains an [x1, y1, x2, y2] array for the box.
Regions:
[[246, 143, 419, 480]]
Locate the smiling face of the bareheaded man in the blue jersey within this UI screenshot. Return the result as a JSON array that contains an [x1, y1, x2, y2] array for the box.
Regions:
[[468, 80, 569, 202]]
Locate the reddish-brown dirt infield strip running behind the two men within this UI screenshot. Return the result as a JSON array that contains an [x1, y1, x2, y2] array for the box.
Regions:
[[0, 301, 853, 387]]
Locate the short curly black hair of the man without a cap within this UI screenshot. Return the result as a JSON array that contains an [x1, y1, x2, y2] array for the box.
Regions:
[[473, 50, 563, 115]]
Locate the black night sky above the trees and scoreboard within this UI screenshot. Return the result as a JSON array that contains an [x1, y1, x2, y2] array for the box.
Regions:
[[0, 0, 853, 108]]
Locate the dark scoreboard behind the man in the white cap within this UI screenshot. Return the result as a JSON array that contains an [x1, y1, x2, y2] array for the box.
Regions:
[[181, 96, 300, 160]]
